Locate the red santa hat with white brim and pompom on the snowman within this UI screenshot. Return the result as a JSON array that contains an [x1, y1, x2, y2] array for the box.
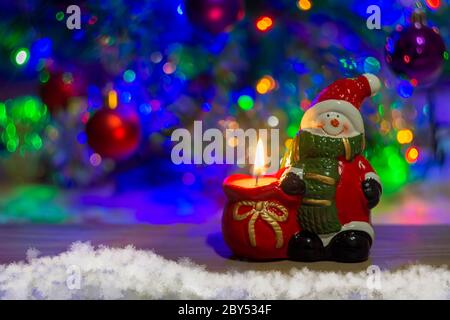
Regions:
[[300, 73, 381, 133]]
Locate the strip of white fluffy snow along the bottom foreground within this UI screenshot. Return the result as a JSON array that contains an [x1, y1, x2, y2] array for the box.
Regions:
[[0, 243, 450, 299]]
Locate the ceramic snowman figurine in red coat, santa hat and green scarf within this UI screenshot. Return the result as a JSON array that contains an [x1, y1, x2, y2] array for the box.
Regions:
[[280, 74, 382, 262]]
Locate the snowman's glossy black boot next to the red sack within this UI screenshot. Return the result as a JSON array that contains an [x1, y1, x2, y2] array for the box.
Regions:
[[288, 230, 325, 262]]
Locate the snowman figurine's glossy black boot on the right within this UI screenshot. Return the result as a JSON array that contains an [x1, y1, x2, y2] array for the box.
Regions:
[[326, 230, 372, 262]]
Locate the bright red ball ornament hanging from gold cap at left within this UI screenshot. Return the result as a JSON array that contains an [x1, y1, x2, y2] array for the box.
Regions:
[[86, 107, 141, 160]]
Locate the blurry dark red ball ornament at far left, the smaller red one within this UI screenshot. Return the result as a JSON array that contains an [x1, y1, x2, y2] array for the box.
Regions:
[[39, 70, 86, 114]]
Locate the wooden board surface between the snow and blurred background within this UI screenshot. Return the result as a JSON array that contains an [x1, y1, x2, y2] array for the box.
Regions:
[[0, 221, 450, 272]]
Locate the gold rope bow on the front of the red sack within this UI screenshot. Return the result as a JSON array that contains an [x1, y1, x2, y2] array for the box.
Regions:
[[233, 201, 289, 249]]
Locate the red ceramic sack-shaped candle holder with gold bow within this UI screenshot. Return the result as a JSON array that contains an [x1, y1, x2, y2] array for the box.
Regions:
[[222, 169, 301, 260]]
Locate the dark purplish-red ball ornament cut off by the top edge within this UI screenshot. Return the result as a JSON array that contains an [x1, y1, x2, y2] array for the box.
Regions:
[[184, 0, 244, 34]]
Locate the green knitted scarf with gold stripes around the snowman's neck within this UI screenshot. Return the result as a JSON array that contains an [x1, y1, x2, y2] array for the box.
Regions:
[[294, 131, 364, 234]]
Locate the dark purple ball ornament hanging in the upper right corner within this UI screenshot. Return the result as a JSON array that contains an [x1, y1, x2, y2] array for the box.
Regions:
[[385, 10, 446, 86]]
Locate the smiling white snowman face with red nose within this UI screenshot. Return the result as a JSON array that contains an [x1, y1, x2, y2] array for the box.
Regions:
[[317, 111, 356, 137]]
